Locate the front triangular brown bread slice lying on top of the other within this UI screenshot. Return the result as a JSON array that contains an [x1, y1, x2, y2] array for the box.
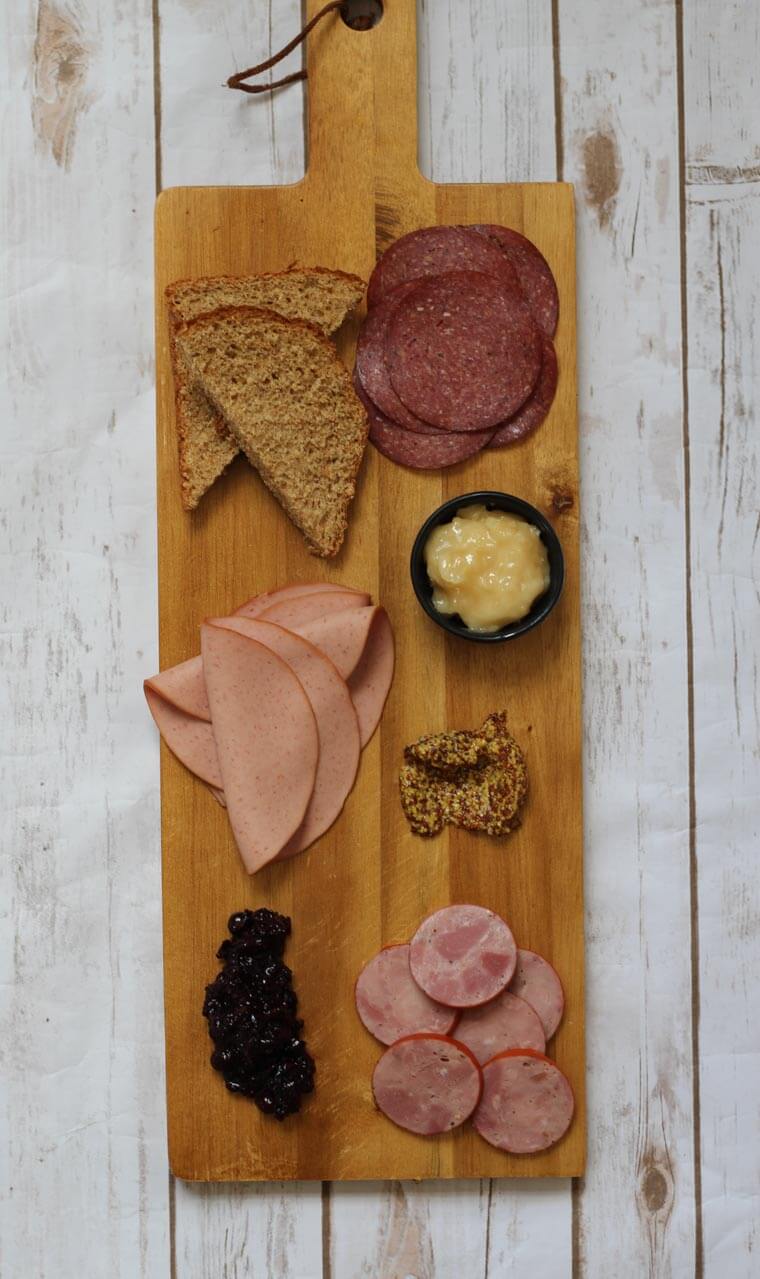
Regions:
[[175, 307, 367, 556]]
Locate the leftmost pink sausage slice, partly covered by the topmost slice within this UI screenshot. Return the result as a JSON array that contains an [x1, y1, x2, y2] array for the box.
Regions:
[[354, 944, 455, 1056]]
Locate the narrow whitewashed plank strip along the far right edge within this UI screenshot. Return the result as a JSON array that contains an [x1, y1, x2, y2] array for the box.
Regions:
[[683, 3, 760, 1279]]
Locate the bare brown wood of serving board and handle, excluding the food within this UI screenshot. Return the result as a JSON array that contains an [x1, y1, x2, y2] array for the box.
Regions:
[[156, 0, 586, 1181]]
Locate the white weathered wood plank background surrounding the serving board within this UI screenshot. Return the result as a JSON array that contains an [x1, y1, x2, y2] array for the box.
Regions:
[[0, 0, 760, 1279]]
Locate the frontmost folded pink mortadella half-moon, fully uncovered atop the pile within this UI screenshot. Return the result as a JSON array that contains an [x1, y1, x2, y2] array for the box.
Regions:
[[201, 622, 319, 875]]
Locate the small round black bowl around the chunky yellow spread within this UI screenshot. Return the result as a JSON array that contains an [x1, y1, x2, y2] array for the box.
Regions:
[[409, 490, 564, 643]]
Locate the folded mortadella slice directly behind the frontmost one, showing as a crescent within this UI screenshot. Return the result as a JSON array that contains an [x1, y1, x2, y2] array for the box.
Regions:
[[208, 618, 361, 857]]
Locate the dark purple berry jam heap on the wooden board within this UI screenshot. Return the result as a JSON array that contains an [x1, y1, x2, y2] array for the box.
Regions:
[[203, 908, 315, 1119]]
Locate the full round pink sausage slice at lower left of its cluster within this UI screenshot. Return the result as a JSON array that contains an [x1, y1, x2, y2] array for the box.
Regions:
[[372, 1035, 482, 1137]]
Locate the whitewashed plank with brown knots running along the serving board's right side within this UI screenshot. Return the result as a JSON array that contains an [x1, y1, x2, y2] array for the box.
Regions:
[[559, 0, 695, 1279]]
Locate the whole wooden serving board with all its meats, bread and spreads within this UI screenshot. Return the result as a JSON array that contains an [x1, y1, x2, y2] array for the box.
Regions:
[[152, 0, 585, 1181]]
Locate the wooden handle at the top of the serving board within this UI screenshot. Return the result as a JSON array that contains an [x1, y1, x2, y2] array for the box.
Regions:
[[306, 0, 417, 188]]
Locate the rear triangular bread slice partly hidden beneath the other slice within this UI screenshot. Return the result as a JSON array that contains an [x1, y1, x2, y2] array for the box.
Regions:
[[166, 266, 365, 510]]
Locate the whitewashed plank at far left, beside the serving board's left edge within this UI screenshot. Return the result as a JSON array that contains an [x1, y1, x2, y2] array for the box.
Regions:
[[0, 0, 169, 1279]]
